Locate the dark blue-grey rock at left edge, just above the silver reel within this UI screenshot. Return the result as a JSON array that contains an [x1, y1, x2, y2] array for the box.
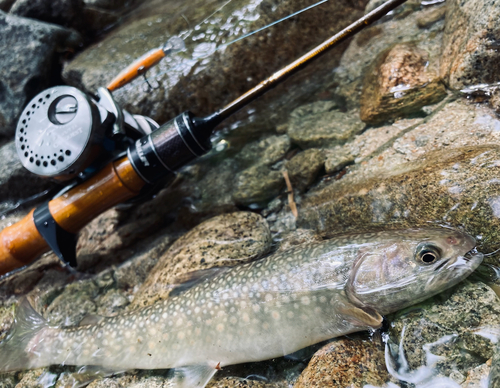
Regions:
[[0, 11, 78, 138]]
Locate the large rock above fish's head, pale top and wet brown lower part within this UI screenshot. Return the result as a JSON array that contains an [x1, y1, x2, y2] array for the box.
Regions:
[[297, 103, 500, 262]]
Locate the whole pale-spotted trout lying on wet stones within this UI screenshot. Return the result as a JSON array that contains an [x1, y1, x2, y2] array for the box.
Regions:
[[0, 229, 482, 387]]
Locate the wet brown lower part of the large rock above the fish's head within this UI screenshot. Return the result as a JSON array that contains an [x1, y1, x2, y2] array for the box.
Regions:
[[297, 146, 500, 260]]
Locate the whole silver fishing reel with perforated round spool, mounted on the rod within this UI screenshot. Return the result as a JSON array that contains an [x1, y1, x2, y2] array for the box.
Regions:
[[15, 86, 158, 181]]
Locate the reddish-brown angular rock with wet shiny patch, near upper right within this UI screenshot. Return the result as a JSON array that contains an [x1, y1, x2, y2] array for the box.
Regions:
[[360, 43, 446, 124]]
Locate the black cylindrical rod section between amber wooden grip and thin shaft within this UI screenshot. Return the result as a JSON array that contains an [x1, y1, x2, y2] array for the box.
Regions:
[[128, 112, 211, 183]]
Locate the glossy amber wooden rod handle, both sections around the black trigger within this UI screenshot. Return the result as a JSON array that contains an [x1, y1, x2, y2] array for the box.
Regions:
[[0, 157, 145, 275]]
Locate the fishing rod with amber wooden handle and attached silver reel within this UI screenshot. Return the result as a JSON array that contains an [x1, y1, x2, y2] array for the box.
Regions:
[[0, 0, 406, 275]]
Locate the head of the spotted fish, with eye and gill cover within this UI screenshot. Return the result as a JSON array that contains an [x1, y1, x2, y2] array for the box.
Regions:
[[346, 228, 483, 314]]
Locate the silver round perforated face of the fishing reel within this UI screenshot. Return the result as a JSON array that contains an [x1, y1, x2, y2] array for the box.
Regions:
[[15, 86, 104, 181]]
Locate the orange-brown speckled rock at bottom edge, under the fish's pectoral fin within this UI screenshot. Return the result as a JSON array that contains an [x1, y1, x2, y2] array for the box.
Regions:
[[294, 336, 389, 388]]
